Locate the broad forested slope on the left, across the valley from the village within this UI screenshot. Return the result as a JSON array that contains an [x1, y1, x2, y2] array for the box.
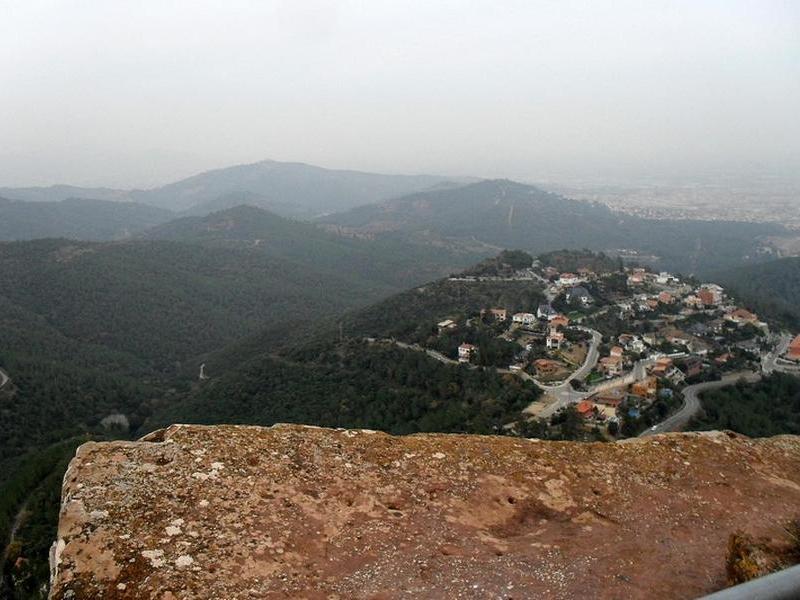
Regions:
[[0, 234, 412, 510]]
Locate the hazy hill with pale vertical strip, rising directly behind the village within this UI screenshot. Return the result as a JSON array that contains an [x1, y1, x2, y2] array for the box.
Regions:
[[322, 180, 783, 273]]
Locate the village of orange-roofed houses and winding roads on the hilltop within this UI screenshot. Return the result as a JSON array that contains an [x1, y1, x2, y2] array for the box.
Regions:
[[412, 251, 800, 439]]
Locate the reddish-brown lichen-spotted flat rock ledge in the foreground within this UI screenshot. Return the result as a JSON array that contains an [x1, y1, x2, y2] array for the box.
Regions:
[[52, 425, 800, 600]]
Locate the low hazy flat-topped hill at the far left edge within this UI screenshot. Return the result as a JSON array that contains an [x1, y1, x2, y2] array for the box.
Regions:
[[0, 198, 174, 241]]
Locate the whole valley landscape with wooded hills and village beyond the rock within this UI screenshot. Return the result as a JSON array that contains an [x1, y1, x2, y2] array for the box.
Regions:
[[0, 166, 797, 591]]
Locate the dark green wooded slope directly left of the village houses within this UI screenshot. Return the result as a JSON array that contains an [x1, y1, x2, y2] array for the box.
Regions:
[[148, 280, 542, 433]]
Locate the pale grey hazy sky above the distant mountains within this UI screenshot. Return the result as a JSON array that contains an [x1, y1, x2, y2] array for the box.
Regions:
[[0, 0, 800, 186]]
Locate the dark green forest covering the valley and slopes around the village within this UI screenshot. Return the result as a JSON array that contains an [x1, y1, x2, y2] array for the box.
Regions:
[[0, 237, 798, 598]]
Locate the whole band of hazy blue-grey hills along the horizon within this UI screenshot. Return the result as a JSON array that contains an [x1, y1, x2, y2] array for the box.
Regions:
[[0, 166, 797, 277]]
